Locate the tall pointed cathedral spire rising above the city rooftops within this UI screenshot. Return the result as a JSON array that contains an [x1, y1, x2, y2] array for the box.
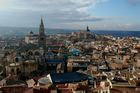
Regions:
[[38, 18, 46, 47]]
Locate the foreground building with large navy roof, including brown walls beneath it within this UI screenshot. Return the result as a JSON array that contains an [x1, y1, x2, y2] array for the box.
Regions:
[[34, 72, 88, 93]]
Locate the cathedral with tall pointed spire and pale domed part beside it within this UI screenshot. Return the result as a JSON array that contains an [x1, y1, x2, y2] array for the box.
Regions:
[[25, 18, 46, 47]]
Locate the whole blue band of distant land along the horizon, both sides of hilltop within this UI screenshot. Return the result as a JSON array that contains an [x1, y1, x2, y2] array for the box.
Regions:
[[0, 27, 140, 38]]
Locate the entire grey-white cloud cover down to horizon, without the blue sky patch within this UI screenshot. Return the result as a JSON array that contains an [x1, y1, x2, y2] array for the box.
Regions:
[[0, 0, 140, 29]]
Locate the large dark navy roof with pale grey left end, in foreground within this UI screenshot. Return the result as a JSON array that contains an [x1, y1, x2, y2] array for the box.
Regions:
[[38, 72, 88, 85]]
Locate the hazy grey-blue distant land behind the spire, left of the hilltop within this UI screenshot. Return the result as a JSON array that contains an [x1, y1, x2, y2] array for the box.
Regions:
[[0, 27, 76, 37]]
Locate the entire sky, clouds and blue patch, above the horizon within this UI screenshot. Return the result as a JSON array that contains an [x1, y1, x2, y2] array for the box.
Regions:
[[0, 0, 140, 31]]
